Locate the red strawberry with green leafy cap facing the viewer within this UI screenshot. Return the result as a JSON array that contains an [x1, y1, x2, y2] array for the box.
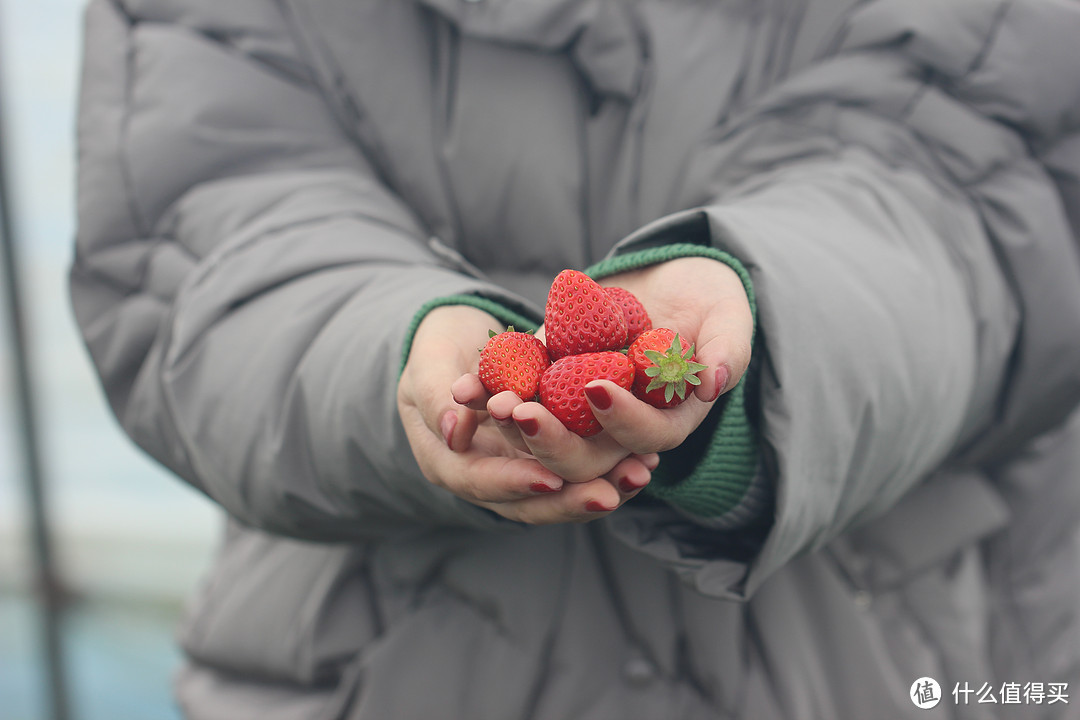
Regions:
[[627, 327, 708, 408]]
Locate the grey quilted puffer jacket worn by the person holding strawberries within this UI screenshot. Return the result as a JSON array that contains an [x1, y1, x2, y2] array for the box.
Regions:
[[71, 0, 1080, 720]]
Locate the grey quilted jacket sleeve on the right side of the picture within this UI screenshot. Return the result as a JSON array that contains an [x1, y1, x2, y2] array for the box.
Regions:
[[611, 0, 1080, 597]]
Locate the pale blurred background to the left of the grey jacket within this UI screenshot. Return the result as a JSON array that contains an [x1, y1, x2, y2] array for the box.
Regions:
[[0, 0, 219, 720]]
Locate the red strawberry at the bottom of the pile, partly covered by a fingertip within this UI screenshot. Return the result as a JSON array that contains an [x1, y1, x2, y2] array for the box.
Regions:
[[540, 351, 634, 437]]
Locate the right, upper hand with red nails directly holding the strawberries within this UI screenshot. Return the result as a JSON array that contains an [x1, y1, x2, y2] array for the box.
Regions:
[[454, 257, 754, 480]]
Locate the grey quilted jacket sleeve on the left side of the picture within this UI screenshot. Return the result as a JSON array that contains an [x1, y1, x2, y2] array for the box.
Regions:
[[71, 0, 533, 539]]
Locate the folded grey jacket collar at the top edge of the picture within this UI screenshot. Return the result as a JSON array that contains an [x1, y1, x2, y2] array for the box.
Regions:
[[419, 0, 645, 99]]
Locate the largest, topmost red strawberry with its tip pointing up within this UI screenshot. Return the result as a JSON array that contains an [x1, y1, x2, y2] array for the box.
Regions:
[[543, 270, 626, 359]]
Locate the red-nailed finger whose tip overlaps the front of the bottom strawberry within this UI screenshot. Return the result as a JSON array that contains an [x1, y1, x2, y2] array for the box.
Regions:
[[583, 380, 712, 453]]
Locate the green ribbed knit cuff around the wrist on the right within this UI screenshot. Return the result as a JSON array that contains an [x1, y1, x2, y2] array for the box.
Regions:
[[585, 243, 758, 518]]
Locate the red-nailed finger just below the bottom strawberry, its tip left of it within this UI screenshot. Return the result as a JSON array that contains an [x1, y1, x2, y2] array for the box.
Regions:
[[512, 403, 631, 483]]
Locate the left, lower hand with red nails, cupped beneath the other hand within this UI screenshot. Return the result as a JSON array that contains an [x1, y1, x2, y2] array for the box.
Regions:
[[397, 305, 659, 524]]
